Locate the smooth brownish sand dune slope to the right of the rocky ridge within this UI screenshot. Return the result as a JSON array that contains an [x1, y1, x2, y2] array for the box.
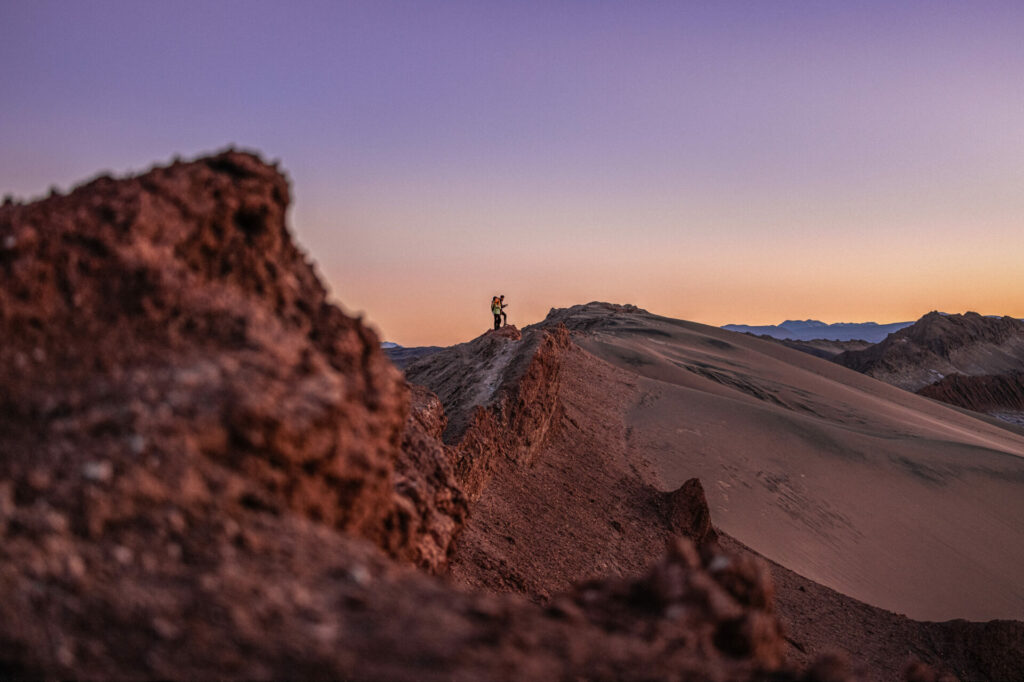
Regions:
[[547, 304, 1024, 621]]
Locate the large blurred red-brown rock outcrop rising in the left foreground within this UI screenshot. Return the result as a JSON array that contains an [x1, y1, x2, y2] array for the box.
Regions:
[[0, 153, 465, 568]]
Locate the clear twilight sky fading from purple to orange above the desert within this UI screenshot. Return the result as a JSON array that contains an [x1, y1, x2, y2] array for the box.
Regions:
[[0, 0, 1024, 346]]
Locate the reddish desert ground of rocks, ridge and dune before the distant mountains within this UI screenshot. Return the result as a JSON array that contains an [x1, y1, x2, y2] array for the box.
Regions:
[[0, 152, 1024, 682]]
